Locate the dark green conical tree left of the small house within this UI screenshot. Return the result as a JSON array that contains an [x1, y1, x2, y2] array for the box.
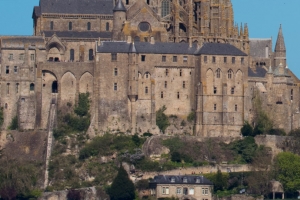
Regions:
[[108, 165, 135, 200]]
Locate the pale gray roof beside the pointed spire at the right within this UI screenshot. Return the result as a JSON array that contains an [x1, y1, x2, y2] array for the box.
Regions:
[[250, 38, 272, 58]]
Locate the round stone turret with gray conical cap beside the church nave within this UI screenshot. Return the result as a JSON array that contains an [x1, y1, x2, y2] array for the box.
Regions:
[[112, 0, 126, 41]]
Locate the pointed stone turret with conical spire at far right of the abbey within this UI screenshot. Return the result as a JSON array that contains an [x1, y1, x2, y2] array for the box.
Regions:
[[274, 25, 286, 66]]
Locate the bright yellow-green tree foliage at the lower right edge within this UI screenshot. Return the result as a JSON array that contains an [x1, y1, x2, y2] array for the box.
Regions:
[[274, 152, 300, 192]]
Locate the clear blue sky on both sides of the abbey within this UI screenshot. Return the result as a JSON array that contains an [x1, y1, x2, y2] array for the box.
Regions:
[[0, 0, 300, 78]]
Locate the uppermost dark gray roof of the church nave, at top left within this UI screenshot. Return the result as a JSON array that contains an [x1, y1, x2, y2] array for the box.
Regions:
[[36, 0, 113, 15]]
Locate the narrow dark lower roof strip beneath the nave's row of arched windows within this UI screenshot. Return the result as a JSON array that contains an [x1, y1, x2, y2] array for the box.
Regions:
[[44, 31, 111, 39]]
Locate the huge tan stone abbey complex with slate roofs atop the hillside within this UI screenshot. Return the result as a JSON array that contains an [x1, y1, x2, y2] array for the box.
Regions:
[[0, 0, 300, 137]]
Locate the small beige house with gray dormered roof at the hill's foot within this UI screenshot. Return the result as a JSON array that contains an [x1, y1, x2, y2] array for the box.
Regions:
[[149, 175, 213, 200]]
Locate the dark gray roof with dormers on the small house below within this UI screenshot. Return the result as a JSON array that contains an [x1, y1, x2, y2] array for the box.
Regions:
[[151, 175, 213, 185]]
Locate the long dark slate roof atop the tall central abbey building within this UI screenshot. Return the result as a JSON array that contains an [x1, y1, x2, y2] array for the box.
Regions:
[[97, 42, 247, 56]]
